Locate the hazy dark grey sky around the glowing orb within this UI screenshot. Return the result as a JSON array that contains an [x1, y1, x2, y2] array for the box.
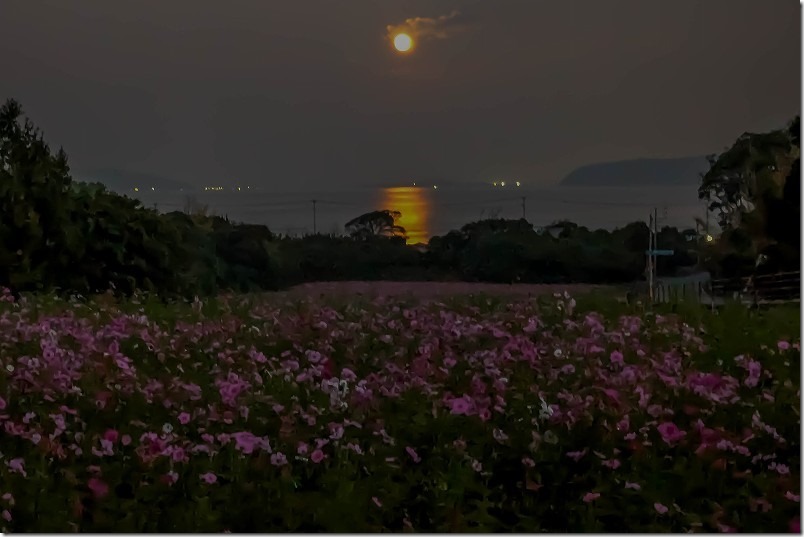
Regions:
[[0, 0, 801, 189]]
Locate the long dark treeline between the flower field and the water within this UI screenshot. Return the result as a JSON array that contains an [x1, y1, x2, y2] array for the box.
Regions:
[[0, 101, 800, 297]]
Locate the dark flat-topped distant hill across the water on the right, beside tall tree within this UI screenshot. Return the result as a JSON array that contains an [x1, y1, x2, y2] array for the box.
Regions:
[[561, 156, 709, 186]]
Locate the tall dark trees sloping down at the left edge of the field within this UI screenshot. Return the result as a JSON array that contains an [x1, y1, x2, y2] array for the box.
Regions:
[[0, 100, 286, 298]]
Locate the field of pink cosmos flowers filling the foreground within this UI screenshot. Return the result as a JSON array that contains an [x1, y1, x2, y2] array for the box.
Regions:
[[0, 286, 801, 532]]
